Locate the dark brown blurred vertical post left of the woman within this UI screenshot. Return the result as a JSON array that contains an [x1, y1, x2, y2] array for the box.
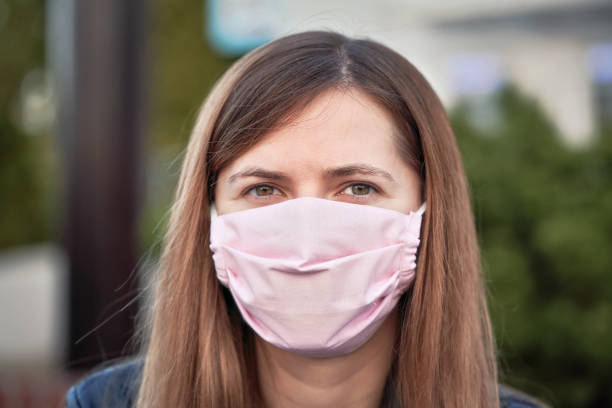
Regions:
[[60, 0, 145, 368]]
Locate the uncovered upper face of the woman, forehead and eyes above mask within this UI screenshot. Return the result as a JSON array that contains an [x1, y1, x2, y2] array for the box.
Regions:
[[215, 89, 422, 214]]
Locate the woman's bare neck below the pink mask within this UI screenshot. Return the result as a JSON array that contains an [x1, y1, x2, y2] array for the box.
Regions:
[[256, 308, 398, 408]]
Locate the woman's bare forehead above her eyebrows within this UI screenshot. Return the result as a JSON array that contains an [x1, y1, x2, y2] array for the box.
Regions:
[[219, 89, 401, 178]]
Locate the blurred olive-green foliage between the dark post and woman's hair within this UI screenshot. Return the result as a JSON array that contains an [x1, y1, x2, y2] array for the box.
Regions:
[[140, 0, 234, 255]]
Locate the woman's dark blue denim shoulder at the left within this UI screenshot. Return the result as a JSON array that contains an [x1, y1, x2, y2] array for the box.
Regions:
[[66, 359, 143, 408]]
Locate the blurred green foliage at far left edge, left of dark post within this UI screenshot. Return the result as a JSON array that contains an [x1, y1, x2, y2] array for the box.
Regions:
[[0, 0, 52, 248]]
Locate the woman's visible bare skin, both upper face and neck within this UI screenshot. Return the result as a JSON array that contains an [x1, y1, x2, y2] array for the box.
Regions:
[[215, 89, 422, 408]]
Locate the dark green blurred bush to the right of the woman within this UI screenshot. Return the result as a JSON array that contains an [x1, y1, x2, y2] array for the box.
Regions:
[[451, 88, 612, 407]]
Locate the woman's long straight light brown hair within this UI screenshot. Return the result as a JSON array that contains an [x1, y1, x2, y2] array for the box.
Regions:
[[137, 31, 499, 408]]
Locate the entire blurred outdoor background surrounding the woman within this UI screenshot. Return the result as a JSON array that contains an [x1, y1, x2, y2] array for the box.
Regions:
[[0, 0, 612, 408]]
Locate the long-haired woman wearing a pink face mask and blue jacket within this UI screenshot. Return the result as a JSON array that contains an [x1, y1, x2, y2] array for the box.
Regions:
[[68, 32, 535, 407]]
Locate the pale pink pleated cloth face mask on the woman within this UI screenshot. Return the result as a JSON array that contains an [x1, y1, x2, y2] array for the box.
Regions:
[[210, 197, 425, 358]]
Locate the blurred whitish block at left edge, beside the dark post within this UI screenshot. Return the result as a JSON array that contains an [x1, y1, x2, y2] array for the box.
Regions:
[[0, 245, 68, 371]]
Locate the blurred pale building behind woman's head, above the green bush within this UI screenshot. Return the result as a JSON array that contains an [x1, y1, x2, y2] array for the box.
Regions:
[[208, 0, 612, 145]]
